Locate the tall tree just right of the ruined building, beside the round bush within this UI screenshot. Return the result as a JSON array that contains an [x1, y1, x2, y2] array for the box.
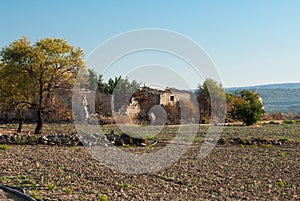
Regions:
[[196, 79, 226, 123]]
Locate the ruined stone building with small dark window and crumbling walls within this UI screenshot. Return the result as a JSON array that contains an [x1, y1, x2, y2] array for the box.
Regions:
[[127, 87, 198, 124]]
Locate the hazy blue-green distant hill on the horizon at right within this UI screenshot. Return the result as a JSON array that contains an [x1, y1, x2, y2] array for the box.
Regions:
[[226, 83, 300, 115]]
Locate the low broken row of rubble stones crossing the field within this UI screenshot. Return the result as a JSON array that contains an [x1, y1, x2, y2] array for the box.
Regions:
[[0, 130, 288, 147]]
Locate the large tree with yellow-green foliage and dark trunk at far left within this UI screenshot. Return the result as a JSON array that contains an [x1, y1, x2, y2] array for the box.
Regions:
[[0, 37, 85, 134]]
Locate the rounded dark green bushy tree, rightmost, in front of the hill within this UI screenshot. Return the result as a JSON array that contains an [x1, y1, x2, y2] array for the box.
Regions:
[[231, 90, 264, 126]]
